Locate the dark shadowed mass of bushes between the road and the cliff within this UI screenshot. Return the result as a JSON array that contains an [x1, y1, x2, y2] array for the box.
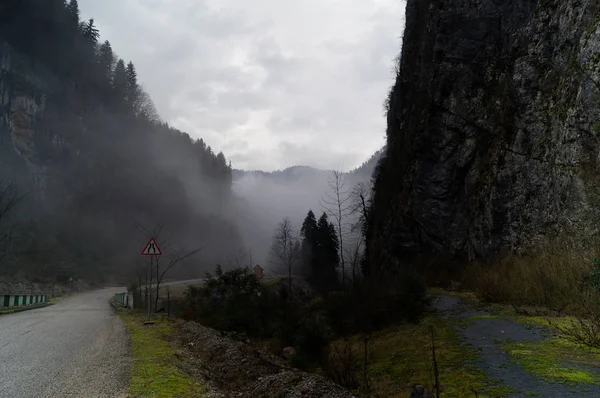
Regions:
[[181, 262, 427, 372]]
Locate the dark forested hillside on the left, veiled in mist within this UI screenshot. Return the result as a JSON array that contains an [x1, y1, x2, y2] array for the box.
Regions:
[[0, 0, 238, 281]]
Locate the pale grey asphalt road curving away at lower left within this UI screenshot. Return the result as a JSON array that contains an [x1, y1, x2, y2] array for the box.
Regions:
[[0, 289, 132, 398]]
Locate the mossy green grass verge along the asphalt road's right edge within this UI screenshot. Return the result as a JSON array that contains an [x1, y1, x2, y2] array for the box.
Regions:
[[118, 311, 207, 398]]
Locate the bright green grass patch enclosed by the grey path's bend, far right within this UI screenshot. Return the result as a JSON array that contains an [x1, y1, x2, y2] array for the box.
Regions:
[[501, 336, 600, 385]]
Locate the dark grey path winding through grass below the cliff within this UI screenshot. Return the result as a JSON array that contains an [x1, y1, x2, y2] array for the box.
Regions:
[[435, 296, 600, 397]]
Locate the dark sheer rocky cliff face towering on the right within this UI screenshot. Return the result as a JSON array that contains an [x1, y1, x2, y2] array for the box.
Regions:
[[371, 0, 600, 266]]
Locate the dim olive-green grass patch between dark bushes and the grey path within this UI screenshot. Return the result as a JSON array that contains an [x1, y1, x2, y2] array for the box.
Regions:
[[338, 315, 513, 397]]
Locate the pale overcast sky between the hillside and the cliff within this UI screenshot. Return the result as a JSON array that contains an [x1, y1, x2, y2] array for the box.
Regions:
[[79, 0, 405, 171]]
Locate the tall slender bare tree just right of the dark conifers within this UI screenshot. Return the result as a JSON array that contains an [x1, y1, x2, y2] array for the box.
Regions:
[[321, 170, 352, 287]]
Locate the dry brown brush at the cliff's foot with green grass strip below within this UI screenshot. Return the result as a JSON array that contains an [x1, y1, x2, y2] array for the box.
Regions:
[[463, 238, 600, 348]]
